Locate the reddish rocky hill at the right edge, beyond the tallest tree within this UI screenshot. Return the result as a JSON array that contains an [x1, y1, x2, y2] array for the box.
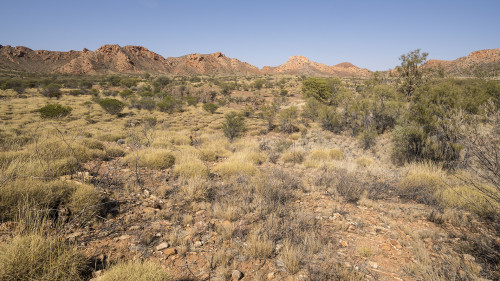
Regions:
[[424, 49, 500, 76]]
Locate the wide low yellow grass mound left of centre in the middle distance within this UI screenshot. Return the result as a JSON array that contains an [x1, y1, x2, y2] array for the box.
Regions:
[[123, 149, 175, 169]]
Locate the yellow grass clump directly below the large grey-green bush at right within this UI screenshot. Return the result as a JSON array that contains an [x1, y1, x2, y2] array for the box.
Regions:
[[399, 163, 446, 204]]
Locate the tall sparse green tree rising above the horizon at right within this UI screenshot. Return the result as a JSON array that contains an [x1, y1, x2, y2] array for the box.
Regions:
[[396, 49, 429, 99]]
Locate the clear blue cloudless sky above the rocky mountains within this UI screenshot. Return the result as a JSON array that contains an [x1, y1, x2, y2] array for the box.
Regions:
[[0, 0, 500, 70]]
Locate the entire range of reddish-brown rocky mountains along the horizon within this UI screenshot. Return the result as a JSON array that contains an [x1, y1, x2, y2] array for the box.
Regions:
[[0, 45, 500, 77]]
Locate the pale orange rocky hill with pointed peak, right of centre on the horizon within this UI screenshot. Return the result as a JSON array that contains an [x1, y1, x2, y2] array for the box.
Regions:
[[262, 56, 371, 77]]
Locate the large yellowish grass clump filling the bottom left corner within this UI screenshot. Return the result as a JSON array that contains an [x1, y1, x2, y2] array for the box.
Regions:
[[0, 234, 87, 281]]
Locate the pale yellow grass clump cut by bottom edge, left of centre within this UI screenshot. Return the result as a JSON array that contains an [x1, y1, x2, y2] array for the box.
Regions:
[[99, 261, 174, 281]]
